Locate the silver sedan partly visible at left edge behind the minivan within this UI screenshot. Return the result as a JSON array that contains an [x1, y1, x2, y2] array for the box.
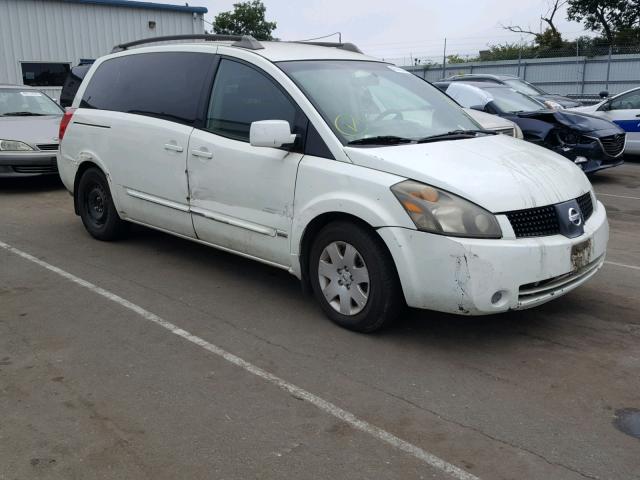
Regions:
[[0, 85, 64, 177]]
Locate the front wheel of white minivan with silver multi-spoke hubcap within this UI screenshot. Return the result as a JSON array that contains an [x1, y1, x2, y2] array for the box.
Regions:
[[309, 221, 405, 333]]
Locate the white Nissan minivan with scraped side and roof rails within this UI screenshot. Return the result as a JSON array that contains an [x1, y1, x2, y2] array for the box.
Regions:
[[58, 36, 609, 332]]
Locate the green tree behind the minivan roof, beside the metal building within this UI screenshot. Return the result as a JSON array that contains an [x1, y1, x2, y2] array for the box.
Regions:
[[213, 0, 276, 40]]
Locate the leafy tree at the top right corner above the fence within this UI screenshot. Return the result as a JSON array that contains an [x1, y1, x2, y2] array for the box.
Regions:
[[567, 0, 640, 45]]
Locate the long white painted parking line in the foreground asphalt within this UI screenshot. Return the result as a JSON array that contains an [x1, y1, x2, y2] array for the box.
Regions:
[[0, 241, 480, 480]]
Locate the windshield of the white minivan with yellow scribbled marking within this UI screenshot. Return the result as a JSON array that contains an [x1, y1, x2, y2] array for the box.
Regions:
[[278, 60, 480, 144]]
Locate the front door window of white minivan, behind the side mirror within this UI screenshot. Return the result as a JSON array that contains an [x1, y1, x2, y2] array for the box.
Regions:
[[206, 59, 299, 142]]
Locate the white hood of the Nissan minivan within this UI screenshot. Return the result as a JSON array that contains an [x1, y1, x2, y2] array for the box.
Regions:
[[345, 135, 591, 213]]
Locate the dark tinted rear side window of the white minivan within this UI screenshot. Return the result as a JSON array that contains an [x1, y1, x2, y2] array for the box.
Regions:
[[80, 52, 215, 125]]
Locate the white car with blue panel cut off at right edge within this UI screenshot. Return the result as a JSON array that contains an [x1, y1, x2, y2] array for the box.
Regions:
[[571, 87, 640, 155]]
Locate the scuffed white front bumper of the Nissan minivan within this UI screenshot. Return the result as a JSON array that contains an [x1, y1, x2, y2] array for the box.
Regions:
[[378, 202, 609, 315]]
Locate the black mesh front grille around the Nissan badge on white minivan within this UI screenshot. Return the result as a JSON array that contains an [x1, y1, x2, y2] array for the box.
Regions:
[[504, 192, 593, 238]]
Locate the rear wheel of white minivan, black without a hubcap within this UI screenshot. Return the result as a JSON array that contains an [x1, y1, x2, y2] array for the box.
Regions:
[[76, 168, 129, 241]]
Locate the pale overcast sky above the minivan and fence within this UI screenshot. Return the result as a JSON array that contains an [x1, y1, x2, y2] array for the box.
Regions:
[[151, 0, 584, 60]]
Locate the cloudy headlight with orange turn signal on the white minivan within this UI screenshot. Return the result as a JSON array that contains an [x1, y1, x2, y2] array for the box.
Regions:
[[391, 180, 502, 238]]
